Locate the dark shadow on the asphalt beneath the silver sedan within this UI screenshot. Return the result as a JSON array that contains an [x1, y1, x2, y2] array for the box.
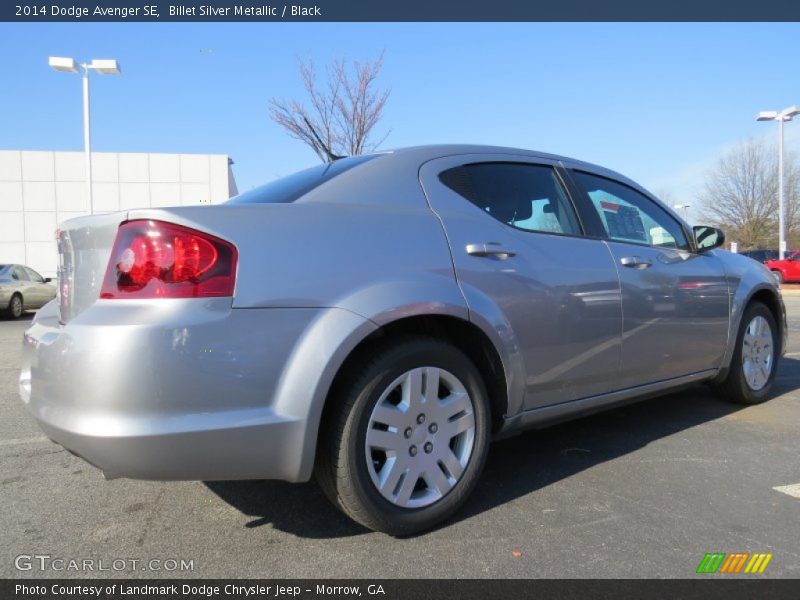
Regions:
[[206, 358, 800, 538]]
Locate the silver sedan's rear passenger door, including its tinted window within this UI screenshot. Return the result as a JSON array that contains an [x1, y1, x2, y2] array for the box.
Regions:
[[420, 154, 622, 413]]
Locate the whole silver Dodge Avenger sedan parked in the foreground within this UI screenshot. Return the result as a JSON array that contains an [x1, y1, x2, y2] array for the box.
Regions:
[[20, 146, 786, 534]]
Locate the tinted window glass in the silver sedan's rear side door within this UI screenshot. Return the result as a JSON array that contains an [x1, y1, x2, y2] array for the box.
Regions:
[[439, 163, 581, 235]]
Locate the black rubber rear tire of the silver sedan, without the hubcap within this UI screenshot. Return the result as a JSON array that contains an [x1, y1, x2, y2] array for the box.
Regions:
[[316, 337, 491, 536]]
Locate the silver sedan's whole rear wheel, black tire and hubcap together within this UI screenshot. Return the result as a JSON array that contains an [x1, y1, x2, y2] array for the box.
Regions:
[[315, 335, 491, 535]]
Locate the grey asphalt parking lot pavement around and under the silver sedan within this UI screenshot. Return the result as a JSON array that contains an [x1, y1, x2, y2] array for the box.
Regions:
[[0, 295, 800, 578]]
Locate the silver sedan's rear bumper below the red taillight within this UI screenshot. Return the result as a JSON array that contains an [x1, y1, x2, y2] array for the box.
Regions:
[[20, 298, 348, 481]]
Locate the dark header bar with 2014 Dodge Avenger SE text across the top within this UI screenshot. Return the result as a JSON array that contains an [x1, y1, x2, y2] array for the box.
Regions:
[[0, 0, 800, 22]]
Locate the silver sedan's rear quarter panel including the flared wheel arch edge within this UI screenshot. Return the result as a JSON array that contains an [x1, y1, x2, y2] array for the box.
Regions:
[[129, 203, 468, 481]]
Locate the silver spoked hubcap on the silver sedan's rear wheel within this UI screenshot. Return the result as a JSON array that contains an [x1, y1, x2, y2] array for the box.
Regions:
[[365, 367, 475, 508]]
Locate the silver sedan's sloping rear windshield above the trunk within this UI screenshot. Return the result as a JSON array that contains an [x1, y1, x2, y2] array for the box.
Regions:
[[228, 154, 381, 204]]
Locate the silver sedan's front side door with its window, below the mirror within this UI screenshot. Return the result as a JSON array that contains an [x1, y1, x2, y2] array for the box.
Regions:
[[571, 171, 730, 388]]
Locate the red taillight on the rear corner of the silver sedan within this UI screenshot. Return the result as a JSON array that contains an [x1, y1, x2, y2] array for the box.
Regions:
[[100, 221, 237, 298]]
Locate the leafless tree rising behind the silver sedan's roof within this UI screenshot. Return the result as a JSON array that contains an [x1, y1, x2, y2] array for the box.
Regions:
[[269, 53, 389, 162]]
